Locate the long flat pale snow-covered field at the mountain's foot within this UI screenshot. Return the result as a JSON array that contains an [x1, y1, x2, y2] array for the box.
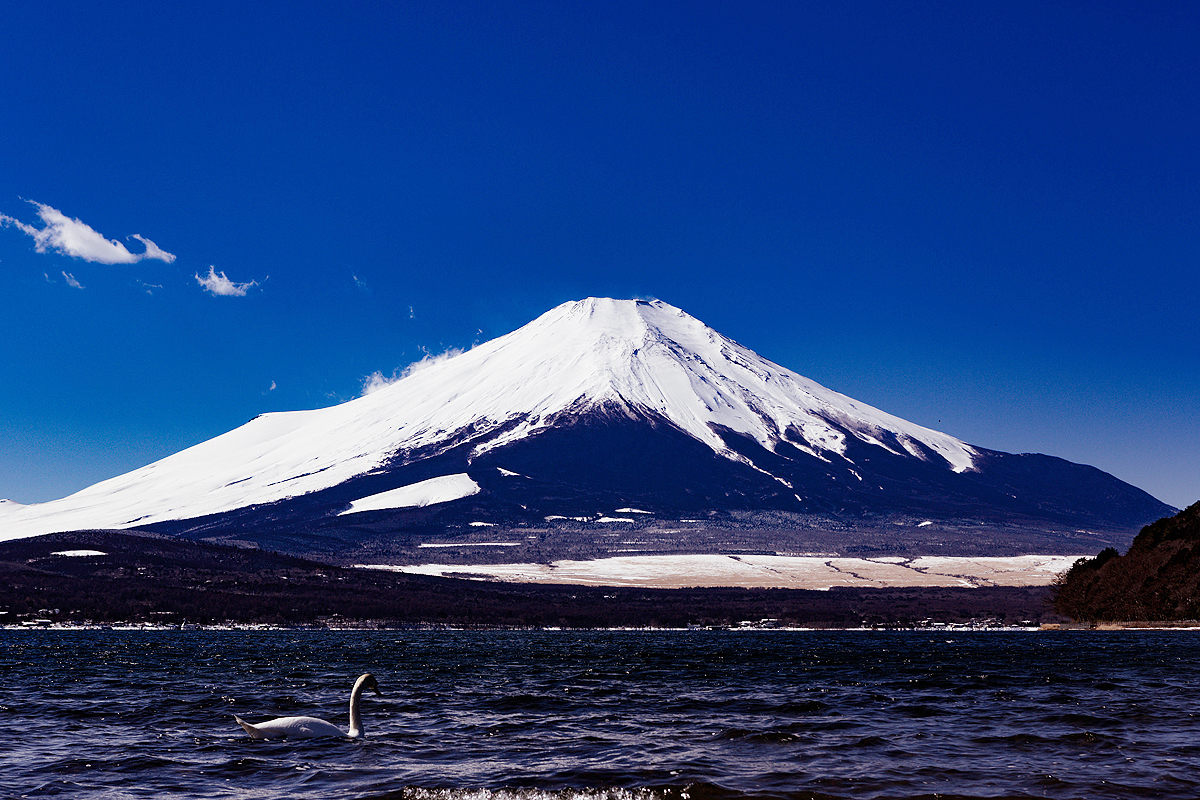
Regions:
[[359, 555, 1081, 590]]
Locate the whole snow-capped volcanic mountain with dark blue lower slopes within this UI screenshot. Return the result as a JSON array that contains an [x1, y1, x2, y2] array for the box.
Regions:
[[0, 297, 1174, 557]]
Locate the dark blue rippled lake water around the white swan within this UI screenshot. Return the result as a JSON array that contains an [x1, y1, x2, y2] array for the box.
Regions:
[[0, 631, 1200, 800]]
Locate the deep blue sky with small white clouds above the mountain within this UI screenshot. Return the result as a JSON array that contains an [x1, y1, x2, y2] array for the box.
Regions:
[[0, 1, 1200, 506]]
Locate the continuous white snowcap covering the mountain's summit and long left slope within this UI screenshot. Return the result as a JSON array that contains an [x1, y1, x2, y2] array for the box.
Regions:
[[0, 297, 979, 540]]
